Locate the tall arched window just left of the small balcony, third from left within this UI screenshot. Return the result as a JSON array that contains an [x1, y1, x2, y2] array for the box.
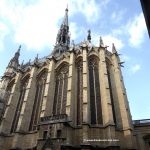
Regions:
[[29, 70, 48, 131]]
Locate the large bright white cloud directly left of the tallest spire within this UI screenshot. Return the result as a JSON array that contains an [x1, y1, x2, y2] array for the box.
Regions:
[[15, 0, 66, 50]]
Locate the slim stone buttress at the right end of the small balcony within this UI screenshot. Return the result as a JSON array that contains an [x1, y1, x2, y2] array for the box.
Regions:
[[66, 52, 76, 120]]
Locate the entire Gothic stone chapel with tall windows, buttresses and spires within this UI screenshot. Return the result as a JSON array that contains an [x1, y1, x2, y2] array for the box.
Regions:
[[0, 9, 150, 150]]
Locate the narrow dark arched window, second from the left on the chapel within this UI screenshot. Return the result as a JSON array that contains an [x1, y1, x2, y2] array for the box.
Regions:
[[11, 76, 29, 133]]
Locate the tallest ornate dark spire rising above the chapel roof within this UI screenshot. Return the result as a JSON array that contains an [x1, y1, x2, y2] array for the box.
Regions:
[[53, 7, 70, 54]]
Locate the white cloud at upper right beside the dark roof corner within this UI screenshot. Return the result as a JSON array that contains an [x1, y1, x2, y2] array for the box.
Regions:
[[127, 13, 146, 47]]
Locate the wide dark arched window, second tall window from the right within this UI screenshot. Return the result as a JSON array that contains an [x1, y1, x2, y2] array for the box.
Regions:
[[88, 56, 102, 125]]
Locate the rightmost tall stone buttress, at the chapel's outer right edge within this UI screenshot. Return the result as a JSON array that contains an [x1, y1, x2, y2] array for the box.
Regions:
[[112, 53, 133, 148]]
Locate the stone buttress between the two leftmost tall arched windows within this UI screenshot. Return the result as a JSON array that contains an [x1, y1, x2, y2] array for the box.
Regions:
[[0, 73, 22, 134]]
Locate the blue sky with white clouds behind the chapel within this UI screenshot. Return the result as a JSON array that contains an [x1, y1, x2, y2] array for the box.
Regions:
[[0, 0, 150, 119]]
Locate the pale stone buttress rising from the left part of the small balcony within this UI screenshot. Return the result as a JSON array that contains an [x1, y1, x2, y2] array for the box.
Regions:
[[41, 58, 55, 117]]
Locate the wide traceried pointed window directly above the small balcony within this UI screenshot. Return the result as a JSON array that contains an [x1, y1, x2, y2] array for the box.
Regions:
[[53, 64, 69, 115]]
